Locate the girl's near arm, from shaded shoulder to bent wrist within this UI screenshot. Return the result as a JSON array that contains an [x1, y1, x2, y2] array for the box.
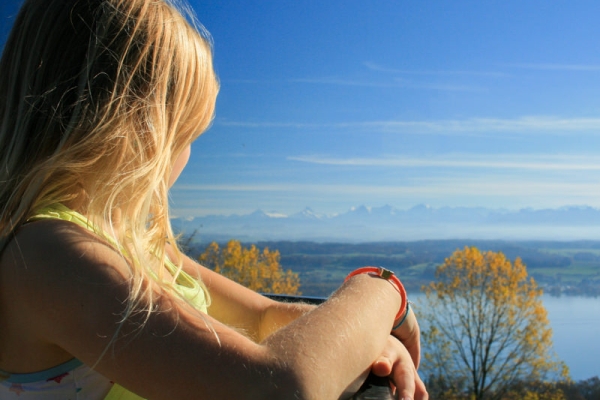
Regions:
[[7, 221, 419, 399]]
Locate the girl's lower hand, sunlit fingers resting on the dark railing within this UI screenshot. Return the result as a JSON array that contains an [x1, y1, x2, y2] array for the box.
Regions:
[[371, 336, 429, 400]]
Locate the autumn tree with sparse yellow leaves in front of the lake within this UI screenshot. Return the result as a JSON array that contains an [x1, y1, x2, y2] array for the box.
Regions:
[[420, 247, 568, 400]]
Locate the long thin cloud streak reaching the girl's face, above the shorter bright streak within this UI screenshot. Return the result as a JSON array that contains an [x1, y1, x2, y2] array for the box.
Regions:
[[220, 116, 600, 135]]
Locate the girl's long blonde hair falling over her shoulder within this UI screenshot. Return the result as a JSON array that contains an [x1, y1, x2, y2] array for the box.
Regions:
[[0, 0, 218, 318]]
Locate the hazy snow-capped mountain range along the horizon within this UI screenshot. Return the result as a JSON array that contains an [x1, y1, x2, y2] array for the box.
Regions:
[[171, 204, 600, 243]]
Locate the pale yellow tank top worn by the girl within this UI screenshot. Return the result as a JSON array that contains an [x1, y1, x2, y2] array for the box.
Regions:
[[28, 204, 208, 400]]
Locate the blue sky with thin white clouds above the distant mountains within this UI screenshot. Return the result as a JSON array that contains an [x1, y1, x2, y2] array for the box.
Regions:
[[5, 0, 600, 216]]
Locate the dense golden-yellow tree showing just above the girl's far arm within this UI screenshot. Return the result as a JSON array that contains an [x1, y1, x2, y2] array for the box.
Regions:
[[199, 240, 302, 295]]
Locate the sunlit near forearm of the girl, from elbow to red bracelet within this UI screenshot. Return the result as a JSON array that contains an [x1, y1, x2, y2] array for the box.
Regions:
[[263, 275, 400, 399]]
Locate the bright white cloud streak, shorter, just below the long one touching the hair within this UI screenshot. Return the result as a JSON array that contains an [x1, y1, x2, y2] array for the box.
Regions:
[[287, 154, 600, 171]]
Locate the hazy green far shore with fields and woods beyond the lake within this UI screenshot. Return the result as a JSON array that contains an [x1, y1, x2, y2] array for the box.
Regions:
[[182, 235, 600, 297]]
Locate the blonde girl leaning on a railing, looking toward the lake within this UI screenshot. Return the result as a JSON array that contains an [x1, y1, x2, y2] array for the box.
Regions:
[[0, 0, 427, 400]]
